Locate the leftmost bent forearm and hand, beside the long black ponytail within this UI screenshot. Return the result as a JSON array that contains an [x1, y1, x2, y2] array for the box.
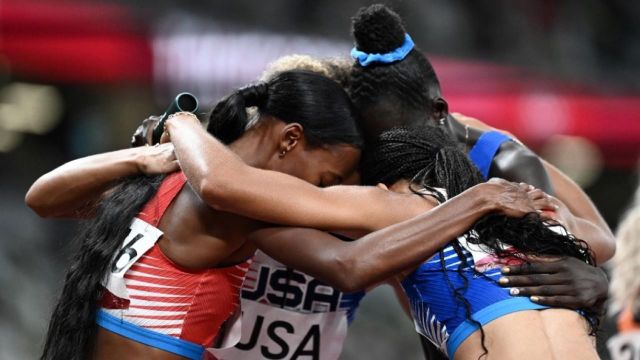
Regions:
[[25, 144, 179, 218]]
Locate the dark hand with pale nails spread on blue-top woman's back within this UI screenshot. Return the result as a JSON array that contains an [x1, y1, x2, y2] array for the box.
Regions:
[[498, 257, 609, 309]]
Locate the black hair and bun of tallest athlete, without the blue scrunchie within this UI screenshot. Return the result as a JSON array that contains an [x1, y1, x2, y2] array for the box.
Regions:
[[349, 4, 440, 140]]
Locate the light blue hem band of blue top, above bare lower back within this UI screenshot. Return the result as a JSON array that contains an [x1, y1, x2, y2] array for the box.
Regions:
[[447, 297, 549, 359]]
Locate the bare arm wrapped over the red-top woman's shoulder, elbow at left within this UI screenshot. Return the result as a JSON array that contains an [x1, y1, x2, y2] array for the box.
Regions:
[[166, 114, 448, 232]]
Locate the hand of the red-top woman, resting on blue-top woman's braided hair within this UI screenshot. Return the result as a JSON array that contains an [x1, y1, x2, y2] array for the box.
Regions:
[[481, 178, 553, 217]]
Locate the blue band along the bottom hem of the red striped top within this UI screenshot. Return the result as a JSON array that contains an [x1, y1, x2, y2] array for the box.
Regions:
[[96, 310, 205, 360]]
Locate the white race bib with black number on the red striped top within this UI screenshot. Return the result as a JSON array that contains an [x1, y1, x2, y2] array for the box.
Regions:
[[103, 218, 162, 299]]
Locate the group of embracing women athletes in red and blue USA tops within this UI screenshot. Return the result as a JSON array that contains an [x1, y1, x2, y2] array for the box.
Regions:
[[26, 5, 615, 360]]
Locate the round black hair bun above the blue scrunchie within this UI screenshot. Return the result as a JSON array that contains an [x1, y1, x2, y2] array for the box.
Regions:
[[352, 4, 405, 54]]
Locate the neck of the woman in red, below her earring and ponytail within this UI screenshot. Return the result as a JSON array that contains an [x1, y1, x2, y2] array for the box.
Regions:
[[229, 121, 275, 169]]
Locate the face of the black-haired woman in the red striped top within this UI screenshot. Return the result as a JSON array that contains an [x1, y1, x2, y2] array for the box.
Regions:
[[274, 145, 360, 187]]
